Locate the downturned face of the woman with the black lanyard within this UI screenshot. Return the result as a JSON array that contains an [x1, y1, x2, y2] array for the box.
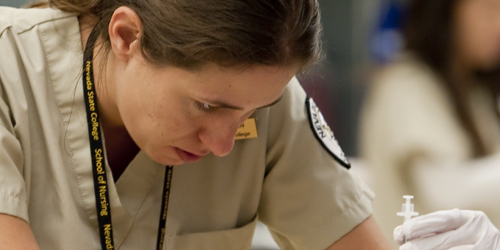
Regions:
[[114, 57, 295, 165]]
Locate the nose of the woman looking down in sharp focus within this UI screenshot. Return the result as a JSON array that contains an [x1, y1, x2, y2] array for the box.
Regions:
[[198, 121, 238, 157]]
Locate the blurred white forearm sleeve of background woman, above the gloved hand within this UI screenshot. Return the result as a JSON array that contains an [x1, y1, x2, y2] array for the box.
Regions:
[[411, 152, 500, 210]]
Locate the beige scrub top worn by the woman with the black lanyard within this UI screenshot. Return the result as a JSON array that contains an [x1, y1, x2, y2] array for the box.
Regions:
[[0, 7, 373, 250]]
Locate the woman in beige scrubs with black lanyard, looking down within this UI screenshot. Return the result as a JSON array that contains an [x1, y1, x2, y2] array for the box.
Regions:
[[0, 0, 386, 249]]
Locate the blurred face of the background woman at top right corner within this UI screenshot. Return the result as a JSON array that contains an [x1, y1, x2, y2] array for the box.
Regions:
[[454, 0, 500, 69]]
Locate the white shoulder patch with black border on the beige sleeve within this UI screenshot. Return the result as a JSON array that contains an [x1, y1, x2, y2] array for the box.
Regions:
[[306, 97, 351, 169]]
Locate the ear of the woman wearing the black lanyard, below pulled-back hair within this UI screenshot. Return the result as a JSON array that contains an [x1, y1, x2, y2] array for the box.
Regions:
[[108, 6, 142, 62]]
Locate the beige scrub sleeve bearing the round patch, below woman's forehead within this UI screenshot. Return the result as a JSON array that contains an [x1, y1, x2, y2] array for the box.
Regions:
[[259, 79, 373, 249]]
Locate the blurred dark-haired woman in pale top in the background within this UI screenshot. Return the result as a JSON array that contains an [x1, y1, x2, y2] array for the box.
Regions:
[[361, 0, 500, 244]]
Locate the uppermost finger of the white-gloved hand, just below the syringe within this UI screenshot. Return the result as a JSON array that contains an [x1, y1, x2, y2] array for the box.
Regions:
[[402, 209, 473, 239]]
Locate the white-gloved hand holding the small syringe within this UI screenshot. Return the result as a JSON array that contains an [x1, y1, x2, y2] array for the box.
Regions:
[[394, 209, 500, 250]]
